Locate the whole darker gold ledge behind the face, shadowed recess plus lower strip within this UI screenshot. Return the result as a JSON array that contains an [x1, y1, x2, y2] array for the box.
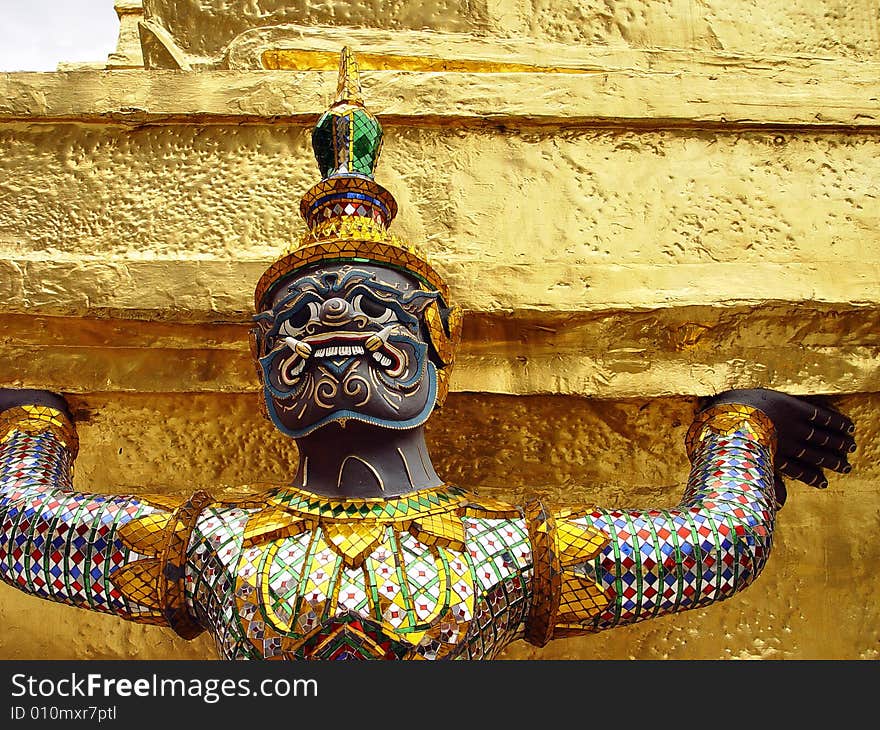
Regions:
[[0, 304, 880, 398]]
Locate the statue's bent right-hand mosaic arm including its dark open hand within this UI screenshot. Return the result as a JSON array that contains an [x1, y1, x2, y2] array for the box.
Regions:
[[524, 390, 855, 638]]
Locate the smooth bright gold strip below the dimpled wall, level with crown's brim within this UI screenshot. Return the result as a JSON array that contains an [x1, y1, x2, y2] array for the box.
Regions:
[[0, 256, 880, 322]]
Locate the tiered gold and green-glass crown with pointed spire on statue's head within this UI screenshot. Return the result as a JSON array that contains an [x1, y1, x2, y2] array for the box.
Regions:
[[254, 48, 449, 312]]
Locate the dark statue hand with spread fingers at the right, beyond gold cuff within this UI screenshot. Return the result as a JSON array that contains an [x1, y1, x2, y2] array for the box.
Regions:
[[704, 388, 856, 494]]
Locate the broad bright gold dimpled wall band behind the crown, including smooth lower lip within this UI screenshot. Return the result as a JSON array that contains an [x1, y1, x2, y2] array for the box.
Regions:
[[0, 124, 880, 324]]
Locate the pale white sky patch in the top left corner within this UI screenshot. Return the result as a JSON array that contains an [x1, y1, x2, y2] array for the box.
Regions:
[[0, 0, 119, 72]]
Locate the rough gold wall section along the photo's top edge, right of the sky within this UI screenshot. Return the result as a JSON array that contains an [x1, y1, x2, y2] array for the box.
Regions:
[[144, 0, 880, 62]]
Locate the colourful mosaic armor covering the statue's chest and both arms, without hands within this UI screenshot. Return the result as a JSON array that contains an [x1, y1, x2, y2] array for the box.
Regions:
[[0, 405, 777, 659]]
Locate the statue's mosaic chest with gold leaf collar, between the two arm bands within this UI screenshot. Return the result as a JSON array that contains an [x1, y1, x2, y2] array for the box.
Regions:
[[235, 487, 531, 659]]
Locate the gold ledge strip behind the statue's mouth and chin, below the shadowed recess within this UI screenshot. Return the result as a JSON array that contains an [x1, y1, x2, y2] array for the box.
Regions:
[[0, 347, 880, 398]]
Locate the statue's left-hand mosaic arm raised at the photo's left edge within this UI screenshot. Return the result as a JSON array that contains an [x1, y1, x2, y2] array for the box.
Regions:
[[0, 389, 207, 636]]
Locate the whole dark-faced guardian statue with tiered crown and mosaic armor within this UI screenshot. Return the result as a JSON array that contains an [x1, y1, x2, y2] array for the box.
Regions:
[[0, 49, 855, 659]]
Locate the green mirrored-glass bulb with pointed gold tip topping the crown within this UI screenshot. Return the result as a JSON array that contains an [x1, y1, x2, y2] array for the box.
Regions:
[[312, 47, 382, 180]]
